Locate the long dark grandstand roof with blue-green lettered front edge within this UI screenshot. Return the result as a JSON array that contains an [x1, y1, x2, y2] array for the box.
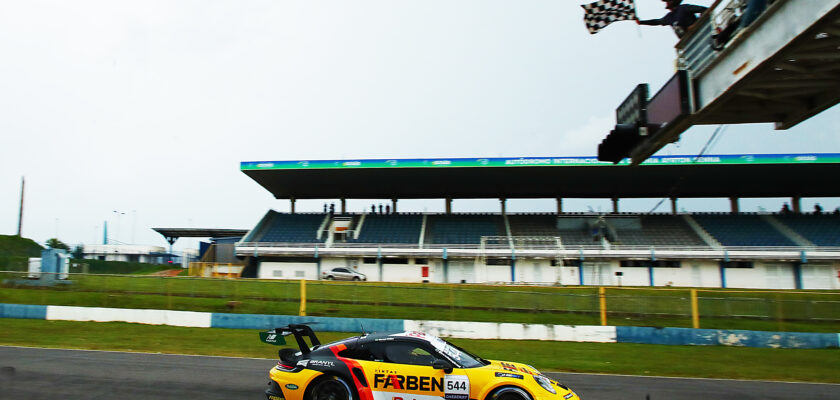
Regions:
[[241, 154, 840, 199]]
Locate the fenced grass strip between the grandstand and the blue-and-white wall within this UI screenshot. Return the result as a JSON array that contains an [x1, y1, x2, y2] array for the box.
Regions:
[[0, 273, 840, 332]]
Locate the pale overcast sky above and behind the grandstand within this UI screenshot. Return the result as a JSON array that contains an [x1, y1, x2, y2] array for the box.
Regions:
[[0, 0, 840, 248]]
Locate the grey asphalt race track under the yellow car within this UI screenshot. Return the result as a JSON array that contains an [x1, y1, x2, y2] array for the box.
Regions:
[[0, 346, 840, 400]]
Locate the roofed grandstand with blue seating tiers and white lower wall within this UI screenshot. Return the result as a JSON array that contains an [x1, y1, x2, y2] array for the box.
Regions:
[[236, 154, 840, 289]]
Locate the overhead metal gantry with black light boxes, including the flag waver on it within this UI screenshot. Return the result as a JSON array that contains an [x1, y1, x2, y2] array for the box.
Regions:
[[599, 0, 840, 165]]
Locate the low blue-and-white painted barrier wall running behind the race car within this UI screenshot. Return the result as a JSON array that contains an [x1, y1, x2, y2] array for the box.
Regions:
[[0, 304, 840, 349]]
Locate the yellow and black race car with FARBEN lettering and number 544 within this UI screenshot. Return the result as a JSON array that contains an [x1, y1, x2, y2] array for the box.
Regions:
[[260, 325, 579, 400]]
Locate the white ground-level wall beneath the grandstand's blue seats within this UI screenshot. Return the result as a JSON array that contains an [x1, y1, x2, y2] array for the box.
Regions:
[[258, 257, 840, 289]]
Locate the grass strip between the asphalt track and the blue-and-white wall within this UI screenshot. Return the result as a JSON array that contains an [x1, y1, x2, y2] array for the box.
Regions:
[[0, 319, 840, 383]]
